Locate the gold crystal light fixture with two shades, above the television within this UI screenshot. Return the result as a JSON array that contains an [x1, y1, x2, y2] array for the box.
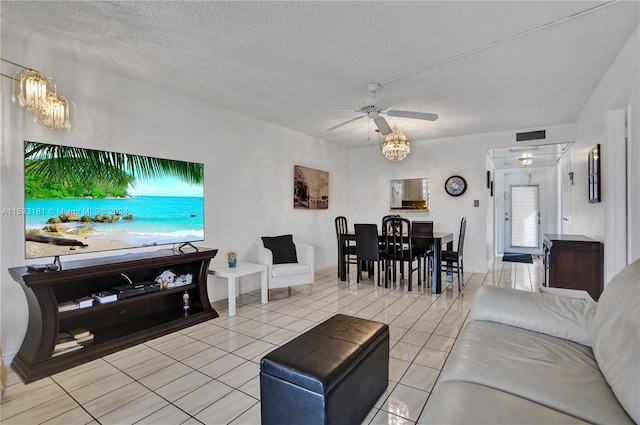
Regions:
[[0, 58, 77, 133]]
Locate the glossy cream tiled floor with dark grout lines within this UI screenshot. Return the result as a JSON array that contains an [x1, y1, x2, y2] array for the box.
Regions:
[[0, 253, 542, 425]]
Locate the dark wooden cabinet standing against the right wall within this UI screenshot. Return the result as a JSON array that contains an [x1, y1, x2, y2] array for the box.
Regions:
[[544, 234, 604, 301]]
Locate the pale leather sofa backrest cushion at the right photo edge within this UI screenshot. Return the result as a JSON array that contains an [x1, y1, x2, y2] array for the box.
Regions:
[[592, 260, 640, 423]]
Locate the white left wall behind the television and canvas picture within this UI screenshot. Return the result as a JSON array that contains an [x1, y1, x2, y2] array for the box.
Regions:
[[0, 33, 348, 361]]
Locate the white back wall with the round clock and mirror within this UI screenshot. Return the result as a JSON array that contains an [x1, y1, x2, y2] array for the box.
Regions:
[[349, 124, 575, 273]]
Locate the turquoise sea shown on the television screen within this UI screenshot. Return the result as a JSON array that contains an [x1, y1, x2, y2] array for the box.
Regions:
[[25, 196, 204, 245]]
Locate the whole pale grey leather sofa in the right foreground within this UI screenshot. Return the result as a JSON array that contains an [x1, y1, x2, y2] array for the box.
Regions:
[[420, 260, 640, 425]]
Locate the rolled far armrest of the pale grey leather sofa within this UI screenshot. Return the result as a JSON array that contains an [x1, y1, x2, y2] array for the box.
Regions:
[[471, 286, 598, 347]]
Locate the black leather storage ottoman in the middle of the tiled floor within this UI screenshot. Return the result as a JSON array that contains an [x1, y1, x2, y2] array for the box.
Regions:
[[260, 314, 389, 425]]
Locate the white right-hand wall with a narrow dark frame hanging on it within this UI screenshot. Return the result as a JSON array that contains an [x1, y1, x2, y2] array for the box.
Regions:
[[571, 24, 640, 282]]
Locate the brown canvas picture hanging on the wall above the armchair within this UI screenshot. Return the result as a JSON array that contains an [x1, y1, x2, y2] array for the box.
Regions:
[[293, 165, 329, 210]]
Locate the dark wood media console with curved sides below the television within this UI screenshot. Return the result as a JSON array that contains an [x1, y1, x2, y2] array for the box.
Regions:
[[9, 248, 218, 383]]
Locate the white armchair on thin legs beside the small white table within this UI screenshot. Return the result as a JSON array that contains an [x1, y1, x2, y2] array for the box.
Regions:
[[257, 235, 314, 299]]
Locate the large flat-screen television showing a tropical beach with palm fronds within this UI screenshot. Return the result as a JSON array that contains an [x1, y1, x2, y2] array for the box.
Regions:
[[24, 141, 204, 259]]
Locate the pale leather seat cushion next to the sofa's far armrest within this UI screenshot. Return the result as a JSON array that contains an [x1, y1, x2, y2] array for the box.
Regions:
[[436, 321, 633, 424]]
